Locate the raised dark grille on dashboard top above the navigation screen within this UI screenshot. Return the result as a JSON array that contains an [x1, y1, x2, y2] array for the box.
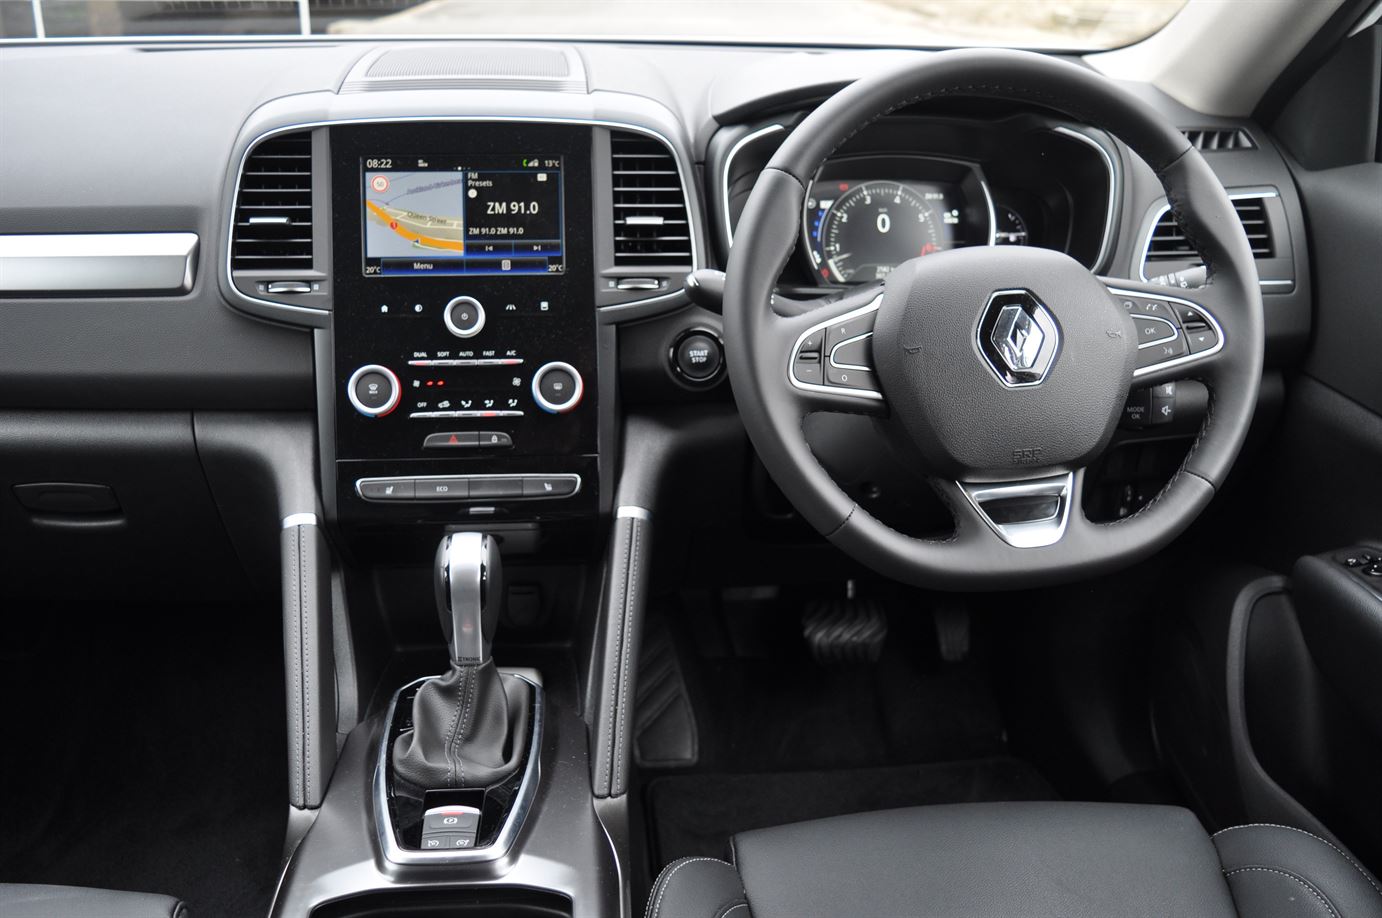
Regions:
[[341, 43, 586, 93]]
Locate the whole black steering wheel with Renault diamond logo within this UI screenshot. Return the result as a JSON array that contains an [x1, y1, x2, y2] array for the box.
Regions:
[[724, 50, 1263, 590]]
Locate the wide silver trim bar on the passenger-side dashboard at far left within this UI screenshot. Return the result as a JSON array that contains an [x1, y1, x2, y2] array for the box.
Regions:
[[0, 232, 199, 296]]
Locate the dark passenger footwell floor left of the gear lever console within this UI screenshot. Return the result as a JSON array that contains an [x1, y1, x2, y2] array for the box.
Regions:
[[0, 606, 287, 918]]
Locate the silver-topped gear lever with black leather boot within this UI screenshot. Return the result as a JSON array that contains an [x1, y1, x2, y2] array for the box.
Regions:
[[392, 532, 529, 795]]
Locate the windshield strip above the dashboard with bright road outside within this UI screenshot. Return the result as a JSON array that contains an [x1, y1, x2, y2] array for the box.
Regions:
[[0, 0, 1186, 50]]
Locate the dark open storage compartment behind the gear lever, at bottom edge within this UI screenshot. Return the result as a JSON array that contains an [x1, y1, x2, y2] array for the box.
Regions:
[[311, 888, 571, 918]]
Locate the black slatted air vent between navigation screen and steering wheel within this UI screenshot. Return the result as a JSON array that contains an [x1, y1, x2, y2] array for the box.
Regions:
[[609, 131, 691, 268]]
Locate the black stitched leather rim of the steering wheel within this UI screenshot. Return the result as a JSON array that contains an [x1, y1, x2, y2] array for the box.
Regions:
[[724, 50, 1263, 590]]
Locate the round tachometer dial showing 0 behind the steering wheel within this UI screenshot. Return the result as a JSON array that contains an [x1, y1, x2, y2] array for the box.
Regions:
[[817, 181, 951, 283]]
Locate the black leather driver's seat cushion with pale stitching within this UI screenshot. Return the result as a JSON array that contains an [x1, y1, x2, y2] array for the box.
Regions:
[[647, 803, 1382, 918]]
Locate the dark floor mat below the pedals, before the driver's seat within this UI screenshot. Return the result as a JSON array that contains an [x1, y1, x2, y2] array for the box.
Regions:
[[647, 756, 1056, 871]]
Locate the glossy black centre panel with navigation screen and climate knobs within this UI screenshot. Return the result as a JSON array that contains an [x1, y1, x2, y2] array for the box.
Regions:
[[330, 122, 600, 524]]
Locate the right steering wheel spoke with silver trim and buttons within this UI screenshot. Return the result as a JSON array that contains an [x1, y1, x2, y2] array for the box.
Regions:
[[1100, 278, 1226, 386]]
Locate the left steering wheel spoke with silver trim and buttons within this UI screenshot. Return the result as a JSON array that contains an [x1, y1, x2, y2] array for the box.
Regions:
[[775, 286, 887, 415]]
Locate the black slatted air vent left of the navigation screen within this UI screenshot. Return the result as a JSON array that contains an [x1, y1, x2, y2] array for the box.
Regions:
[[231, 131, 312, 271]]
